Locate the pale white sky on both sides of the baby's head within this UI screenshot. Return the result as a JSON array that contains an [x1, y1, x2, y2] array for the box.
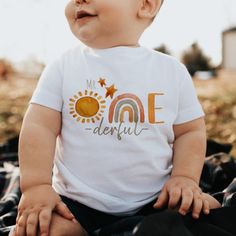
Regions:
[[0, 0, 236, 65]]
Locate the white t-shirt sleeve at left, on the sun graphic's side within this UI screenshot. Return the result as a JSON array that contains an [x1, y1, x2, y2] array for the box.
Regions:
[[30, 58, 63, 112]]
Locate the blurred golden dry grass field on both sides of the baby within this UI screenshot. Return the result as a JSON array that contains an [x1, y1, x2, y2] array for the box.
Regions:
[[0, 71, 236, 157]]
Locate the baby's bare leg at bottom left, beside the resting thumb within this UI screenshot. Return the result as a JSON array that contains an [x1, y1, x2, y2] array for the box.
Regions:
[[49, 213, 88, 236]]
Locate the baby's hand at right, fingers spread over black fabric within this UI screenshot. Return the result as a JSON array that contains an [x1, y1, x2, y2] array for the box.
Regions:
[[154, 176, 210, 218]]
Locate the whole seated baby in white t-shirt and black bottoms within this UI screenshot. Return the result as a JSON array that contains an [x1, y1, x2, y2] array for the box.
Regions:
[[14, 0, 218, 236]]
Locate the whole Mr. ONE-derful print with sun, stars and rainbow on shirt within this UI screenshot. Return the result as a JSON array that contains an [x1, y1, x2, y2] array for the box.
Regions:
[[69, 78, 164, 140]]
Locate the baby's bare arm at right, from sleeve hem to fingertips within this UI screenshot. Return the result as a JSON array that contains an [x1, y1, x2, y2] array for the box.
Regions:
[[154, 118, 206, 218]]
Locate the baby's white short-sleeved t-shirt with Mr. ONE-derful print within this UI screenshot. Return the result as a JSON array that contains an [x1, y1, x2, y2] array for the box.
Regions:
[[31, 46, 204, 215]]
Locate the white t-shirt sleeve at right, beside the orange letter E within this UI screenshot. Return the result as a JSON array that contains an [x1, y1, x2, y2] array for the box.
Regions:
[[174, 65, 204, 125]]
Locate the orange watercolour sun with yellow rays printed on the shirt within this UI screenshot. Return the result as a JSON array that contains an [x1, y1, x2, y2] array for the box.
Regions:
[[69, 90, 106, 123]]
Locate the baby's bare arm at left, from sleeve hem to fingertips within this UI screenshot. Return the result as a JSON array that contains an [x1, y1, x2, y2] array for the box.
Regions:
[[16, 104, 73, 236]]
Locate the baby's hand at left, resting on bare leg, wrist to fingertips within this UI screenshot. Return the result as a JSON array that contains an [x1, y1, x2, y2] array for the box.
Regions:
[[14, 184, 74, 236]]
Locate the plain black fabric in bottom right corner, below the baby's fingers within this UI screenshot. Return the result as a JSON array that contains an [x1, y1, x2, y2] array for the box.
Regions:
[[134, 206, 236, 236]]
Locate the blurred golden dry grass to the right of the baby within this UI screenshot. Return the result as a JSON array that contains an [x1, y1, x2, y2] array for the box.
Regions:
[[194, 71, 236, 157]]
